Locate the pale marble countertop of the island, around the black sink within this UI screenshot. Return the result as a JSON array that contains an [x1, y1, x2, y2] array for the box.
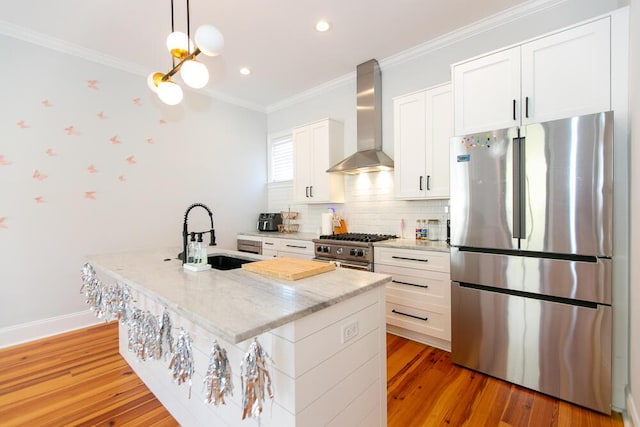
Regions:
[[86, 248, 391, 343]]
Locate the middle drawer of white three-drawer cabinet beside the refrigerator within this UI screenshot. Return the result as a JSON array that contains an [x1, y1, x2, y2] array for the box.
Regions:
[[376, 265, 451, 307]]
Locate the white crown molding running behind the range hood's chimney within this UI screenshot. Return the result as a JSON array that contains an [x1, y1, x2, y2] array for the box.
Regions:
[[266, 0, 567, 114]]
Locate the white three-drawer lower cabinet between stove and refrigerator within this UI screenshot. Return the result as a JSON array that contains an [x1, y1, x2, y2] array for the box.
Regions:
[[374, 247, 451, 351]]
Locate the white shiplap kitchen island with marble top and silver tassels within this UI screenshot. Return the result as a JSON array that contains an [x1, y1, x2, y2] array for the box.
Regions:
[[87, 249, 390, 427]]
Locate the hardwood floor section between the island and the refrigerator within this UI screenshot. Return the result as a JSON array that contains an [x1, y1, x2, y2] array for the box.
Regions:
[[387, 334, 623, 427]]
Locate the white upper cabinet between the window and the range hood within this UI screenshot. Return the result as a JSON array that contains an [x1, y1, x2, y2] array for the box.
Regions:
[[293, 119, 344, 203]]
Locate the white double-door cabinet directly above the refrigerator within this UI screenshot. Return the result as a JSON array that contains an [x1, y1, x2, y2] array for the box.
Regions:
[[452, 17, 611, 136]]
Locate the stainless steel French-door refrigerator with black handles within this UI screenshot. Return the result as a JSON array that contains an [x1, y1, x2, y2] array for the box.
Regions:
[[450, 112, 613, 414]]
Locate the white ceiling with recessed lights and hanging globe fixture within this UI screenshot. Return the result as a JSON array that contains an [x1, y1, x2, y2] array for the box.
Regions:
[[0, 0, 534, 109]]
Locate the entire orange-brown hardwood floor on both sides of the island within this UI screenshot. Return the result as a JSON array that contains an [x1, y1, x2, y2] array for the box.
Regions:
[[0, 323, 622, 427]]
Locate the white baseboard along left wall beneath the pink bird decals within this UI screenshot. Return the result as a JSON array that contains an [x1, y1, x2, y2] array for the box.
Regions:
[[0, 310, 102, 348]]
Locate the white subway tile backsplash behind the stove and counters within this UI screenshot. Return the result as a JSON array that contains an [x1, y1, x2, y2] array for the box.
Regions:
[[267, 172, 449, 239]]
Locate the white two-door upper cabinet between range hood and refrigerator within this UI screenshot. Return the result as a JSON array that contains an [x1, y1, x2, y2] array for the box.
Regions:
[[393, 83, 453, 199]]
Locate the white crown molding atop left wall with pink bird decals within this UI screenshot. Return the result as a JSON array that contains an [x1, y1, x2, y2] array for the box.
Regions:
[[0, 20, 266, 113]]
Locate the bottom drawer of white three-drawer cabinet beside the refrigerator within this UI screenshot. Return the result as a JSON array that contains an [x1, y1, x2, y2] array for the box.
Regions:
[[386, 302, 451, 341]]
